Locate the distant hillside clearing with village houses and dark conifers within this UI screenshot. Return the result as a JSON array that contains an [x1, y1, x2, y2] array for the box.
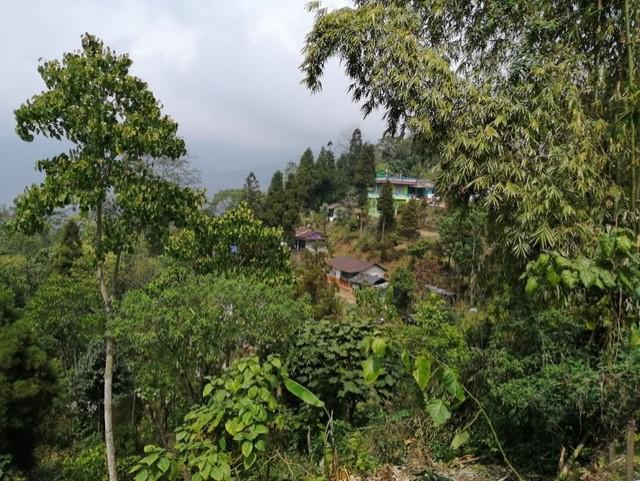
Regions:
[[212, 129, 454, 303]]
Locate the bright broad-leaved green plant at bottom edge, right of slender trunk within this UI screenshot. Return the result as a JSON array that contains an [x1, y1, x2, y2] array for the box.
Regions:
[[131, 356, 322, 481]]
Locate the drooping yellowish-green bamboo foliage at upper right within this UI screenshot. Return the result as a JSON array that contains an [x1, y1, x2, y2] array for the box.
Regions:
[[302, 0, 625, 258]]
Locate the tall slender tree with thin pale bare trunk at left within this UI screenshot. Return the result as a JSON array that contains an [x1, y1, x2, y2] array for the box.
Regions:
[[14, 34, 203, 481]]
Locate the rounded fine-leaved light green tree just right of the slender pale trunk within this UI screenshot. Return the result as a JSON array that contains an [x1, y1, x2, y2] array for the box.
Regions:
[[115, 270, 311, 432]]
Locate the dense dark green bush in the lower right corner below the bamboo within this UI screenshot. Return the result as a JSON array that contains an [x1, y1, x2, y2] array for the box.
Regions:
[[467, 310, 640, 473]]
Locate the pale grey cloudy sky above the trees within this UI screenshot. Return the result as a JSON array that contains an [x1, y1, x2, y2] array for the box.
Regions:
[[0, 0, 383, 205]]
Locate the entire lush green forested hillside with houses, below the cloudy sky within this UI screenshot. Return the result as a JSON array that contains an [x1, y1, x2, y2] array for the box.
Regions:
[[0, 0, 640, 481]]
